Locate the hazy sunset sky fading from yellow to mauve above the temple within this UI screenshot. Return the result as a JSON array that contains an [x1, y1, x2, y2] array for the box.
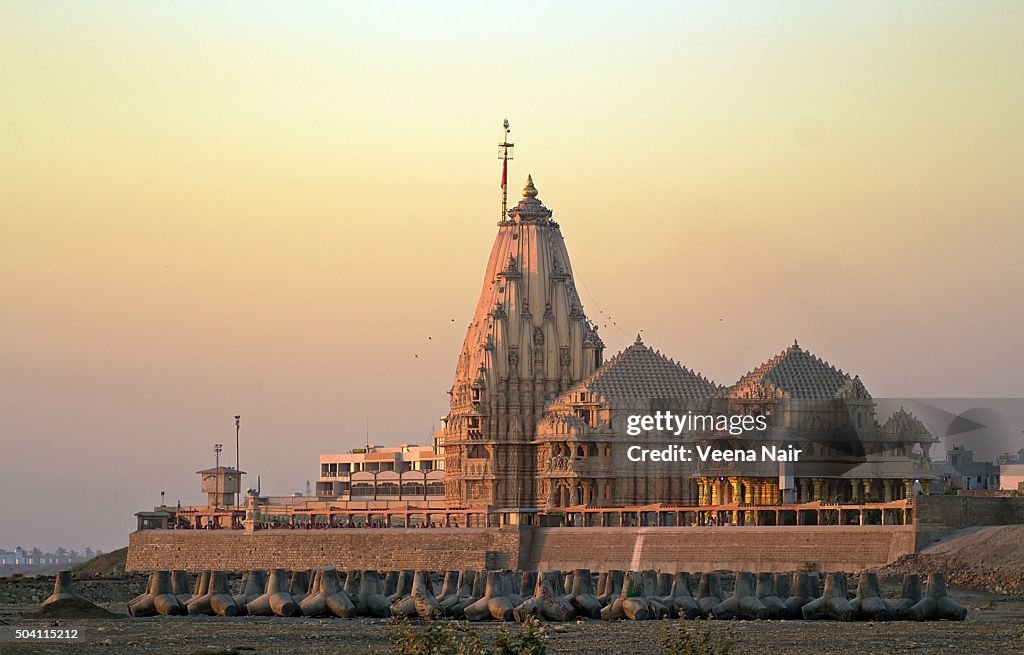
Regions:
[[6, 0, 1024, 550]]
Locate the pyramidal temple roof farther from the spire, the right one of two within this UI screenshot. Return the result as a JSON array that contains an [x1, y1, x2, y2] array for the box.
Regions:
[[727, 341, 866, 400]]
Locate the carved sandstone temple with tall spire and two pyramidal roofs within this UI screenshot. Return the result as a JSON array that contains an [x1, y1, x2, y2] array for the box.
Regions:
[[442, 177, 938, 522]]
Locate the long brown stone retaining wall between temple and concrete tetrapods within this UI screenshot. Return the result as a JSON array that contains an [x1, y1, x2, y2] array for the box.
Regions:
[[127, 526, 914, 571]]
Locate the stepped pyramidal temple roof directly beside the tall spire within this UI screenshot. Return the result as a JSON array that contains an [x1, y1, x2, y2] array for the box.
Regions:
[[556, 335, 722, 402]]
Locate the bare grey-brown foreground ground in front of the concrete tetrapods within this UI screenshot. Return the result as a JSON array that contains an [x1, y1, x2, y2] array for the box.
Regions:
[[0, 577, 1024, 655]]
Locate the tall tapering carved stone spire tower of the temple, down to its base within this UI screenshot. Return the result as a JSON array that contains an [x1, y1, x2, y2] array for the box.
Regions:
[[444, 176, 604, 507]]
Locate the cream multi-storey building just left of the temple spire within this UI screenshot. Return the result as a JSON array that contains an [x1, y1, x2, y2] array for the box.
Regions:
[[316, 438, 444, 501]]
